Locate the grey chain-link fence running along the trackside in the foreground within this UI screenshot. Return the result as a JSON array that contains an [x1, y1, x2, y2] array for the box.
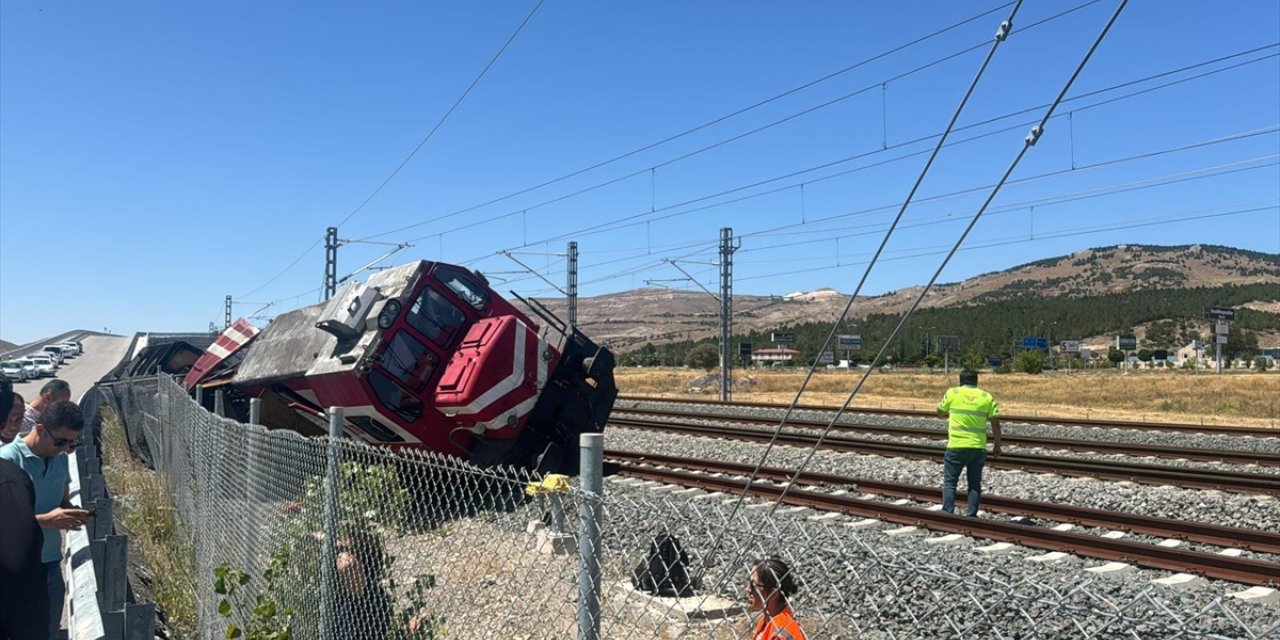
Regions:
[[102, 376, 1280, 640]]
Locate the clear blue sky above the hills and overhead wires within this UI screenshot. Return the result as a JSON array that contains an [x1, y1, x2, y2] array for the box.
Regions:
[[0, 0, 1280, 342]]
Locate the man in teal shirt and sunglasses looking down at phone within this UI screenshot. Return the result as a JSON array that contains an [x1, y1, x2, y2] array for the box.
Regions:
[[0, 401, 90, 636]]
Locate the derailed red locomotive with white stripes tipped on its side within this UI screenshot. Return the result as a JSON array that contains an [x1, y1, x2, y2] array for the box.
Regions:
[[147, 261, 617, 475]]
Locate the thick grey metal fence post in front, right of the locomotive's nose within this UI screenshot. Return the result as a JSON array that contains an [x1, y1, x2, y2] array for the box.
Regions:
[[577, 434, 604, 640]]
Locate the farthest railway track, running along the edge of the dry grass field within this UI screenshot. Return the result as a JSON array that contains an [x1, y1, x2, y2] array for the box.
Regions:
[[617, 396, 1280, 438]]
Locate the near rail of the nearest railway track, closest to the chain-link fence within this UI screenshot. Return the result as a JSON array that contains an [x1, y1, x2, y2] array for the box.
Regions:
[[609, 455, 1280, 585]]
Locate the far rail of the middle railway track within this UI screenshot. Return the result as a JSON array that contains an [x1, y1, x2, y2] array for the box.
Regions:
[[613, 408, 1280, 466]]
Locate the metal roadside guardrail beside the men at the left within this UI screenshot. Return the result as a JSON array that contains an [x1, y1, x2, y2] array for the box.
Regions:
[[63, 387, 156, 640]]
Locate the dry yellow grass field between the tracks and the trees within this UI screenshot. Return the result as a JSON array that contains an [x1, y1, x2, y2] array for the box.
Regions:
[[616, 369, 1280, 428]]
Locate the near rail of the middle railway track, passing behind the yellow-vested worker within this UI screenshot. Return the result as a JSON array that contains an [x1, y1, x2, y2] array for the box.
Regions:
[[609, 417, 1280, 495]]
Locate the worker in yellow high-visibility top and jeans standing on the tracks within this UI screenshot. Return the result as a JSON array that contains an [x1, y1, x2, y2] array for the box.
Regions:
[[938, 369, 1000, 516]]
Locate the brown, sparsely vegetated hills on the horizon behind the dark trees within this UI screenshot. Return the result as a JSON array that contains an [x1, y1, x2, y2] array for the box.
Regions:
[[519, 244, 1280, 355]]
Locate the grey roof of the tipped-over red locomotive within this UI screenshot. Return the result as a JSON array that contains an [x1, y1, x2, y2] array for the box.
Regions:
[[234, 261, 428, 385]]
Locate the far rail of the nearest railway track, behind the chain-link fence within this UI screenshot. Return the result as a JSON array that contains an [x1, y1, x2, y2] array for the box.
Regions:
[[604, 449, 1280, 553]]
